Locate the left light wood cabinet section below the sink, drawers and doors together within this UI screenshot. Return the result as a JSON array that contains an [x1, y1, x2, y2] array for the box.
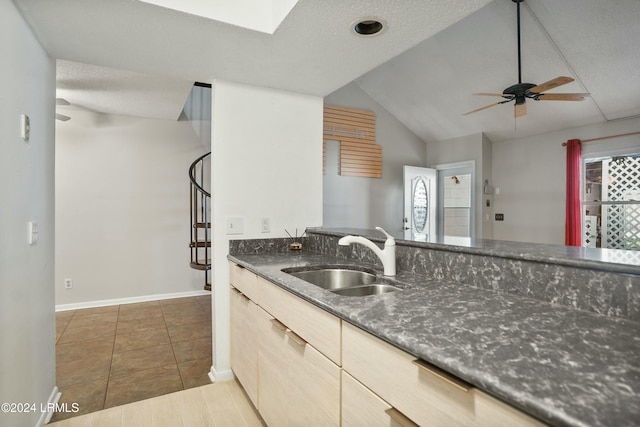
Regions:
[[230, 263, 341, 426]]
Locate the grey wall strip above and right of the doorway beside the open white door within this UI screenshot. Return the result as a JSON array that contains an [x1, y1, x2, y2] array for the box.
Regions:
[[426, 133, 493, 239]]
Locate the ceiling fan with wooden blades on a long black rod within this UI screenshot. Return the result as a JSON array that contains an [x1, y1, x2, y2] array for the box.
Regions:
[[463, 0, 590, 118]]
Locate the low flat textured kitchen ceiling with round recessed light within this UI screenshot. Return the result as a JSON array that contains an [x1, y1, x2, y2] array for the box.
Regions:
[[14, 0, 490, 96]]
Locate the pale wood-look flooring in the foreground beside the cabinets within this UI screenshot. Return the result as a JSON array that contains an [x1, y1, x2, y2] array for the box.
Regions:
[[47, 381, 265, 427]]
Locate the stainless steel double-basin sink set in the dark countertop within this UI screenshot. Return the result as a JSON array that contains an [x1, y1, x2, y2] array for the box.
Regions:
[[282, 266, 401, 297]]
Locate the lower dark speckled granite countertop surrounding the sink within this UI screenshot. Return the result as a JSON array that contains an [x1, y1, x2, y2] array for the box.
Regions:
[[229, 253, 640, 427]]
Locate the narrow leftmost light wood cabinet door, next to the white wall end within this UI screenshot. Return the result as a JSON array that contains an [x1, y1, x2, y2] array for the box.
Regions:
[[230, 288, 258, 407]]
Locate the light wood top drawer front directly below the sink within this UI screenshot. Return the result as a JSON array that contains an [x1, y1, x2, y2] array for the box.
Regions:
[[257, 277, 341, 365]]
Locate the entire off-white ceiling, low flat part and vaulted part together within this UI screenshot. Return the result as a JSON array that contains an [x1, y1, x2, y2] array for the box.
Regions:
[[14, 0, 640, 141]]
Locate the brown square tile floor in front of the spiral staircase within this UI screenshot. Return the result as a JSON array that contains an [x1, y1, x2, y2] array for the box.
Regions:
[[52, 295, 211, 421]]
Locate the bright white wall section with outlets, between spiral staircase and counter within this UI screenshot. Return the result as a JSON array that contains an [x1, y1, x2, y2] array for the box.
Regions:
[[211, 81, 322, 380]]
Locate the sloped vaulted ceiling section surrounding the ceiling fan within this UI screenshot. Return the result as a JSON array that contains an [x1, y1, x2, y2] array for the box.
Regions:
[[357, 0, 640, 141]]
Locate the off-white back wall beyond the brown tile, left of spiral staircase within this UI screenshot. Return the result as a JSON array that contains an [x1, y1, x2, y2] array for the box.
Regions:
[[56, 110, 205, 308]]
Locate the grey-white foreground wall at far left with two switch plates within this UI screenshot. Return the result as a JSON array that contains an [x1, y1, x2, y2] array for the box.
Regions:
[[0, 1, 56, 426]]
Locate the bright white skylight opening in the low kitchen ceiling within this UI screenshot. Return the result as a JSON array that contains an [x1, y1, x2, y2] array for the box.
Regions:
[[140, 0, 298, 34]]
